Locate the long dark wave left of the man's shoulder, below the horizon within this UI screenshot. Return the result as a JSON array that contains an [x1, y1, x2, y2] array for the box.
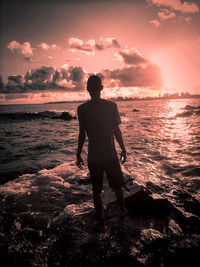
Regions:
[[0, 110, 76, 122]]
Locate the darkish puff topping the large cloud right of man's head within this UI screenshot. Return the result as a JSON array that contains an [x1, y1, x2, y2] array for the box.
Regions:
[[114, 47, 148, 65]]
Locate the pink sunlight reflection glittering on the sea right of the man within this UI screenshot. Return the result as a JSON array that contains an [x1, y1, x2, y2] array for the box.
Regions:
[[123, 100, 199, 190]]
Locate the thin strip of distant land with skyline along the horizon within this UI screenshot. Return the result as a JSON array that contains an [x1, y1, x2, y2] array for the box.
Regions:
[[47, 93, 200, 104]]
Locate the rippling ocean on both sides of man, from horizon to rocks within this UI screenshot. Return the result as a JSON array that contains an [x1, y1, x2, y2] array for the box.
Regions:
[[0, 99, 200, 267]]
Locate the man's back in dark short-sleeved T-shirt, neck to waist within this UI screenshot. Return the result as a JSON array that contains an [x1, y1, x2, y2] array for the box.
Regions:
[[78, 98, 121, 161]]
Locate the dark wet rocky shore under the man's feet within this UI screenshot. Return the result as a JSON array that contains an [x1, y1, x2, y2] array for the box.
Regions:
[[0, 170, 200, 267]]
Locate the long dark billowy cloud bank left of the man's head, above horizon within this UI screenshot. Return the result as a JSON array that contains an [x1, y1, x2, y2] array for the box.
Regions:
[[0, 65, 86, 94]]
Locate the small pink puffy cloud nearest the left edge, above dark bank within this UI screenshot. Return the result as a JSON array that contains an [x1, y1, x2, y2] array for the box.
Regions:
[[7, 41, 33, 58]]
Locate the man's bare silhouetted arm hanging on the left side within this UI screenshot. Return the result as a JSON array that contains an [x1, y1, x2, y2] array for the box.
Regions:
[[76, 109, 86, 168]]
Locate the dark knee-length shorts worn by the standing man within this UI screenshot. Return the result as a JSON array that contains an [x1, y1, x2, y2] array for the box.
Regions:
[[88, 160, 124, 193]]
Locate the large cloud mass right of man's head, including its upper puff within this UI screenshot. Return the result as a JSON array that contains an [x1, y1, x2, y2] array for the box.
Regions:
[[100, 47, 162, 90]]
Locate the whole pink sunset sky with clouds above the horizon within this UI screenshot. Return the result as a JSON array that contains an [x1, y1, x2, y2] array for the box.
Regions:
[[0, 0, 200, 104]]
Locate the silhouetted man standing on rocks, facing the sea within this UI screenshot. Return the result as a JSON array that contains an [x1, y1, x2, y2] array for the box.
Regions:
[[77, 75, 126, 226]]
